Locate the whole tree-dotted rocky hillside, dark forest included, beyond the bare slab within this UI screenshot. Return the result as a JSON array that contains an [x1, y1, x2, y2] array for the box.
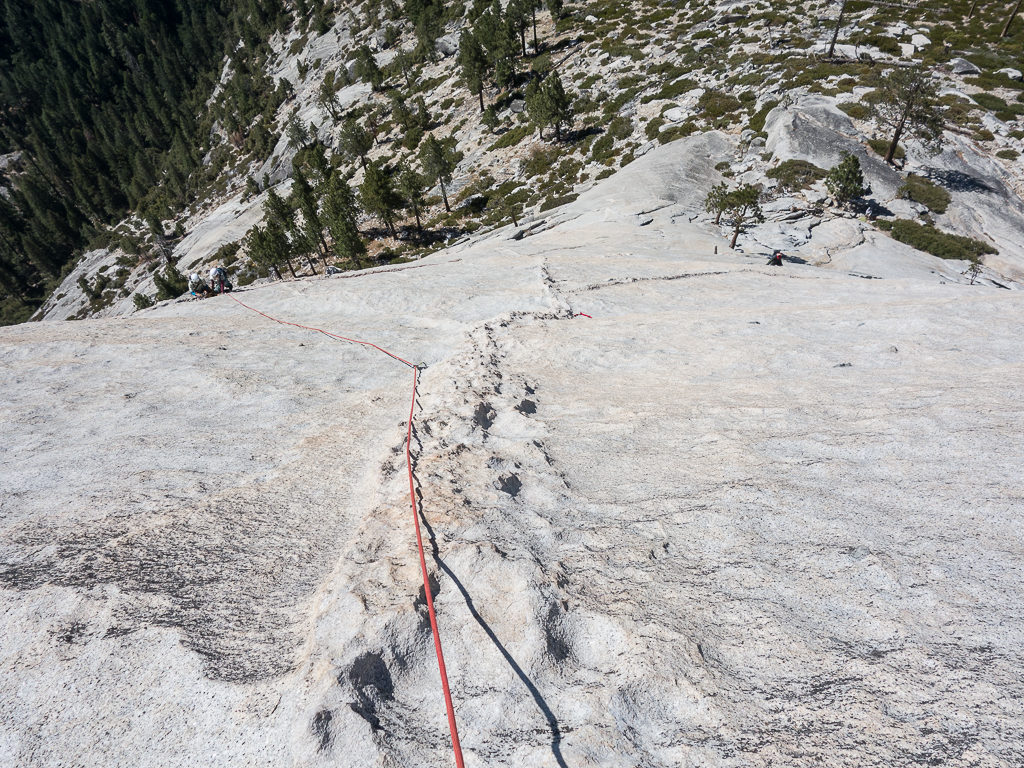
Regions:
[[0, 0, 1024, 322]]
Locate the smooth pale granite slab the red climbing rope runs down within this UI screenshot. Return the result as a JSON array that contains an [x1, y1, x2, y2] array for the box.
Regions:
[[6, 133, 1024, 768]]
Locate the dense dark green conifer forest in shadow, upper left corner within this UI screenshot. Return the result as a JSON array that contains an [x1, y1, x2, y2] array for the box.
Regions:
[[0, 0, 285, 322]]
